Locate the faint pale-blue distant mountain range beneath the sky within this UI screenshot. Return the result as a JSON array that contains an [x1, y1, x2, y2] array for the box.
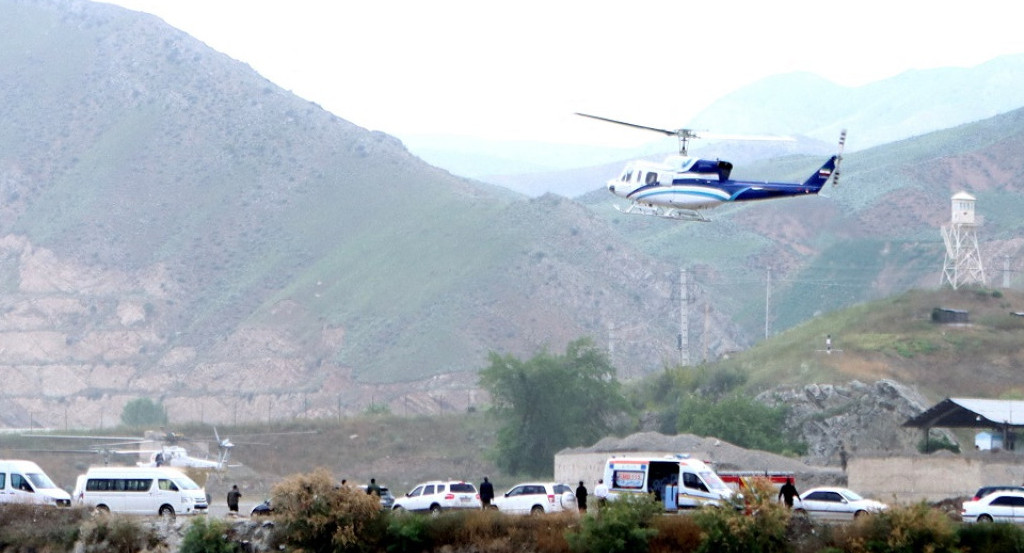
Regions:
[[409, 54, 1024, 198]]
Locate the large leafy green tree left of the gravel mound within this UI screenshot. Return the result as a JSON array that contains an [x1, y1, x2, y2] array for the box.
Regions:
[[480, 339, 629, 475]]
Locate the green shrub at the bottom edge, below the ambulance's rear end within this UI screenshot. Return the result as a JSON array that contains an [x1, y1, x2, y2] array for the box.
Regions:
[[565, 495, 663, 553]]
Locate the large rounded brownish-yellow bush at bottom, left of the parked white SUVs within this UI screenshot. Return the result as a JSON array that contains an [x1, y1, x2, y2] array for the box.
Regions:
[[271, 468, 387, 553]]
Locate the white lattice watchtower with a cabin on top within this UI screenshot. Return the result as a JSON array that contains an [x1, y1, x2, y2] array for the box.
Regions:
[[939, 192, 985, 290]]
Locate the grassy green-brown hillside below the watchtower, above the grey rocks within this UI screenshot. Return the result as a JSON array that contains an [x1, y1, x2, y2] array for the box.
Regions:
[[713, 289, 1024, 399]]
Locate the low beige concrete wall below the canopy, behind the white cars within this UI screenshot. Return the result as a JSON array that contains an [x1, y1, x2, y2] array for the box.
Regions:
[[847, 452, 1024, 504]]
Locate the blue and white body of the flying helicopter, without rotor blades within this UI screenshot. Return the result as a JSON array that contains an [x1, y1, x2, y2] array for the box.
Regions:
[[607, 156, 837, 210]]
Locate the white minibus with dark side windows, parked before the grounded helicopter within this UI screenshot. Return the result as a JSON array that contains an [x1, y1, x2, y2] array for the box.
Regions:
[[75, 467, 208, 516]]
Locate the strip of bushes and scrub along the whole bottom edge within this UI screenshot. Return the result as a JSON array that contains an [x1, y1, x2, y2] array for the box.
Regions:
[[0, 470, 1024, 553]]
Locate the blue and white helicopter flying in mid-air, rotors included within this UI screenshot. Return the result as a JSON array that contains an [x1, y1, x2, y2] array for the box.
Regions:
[[577, 113, 846, 221]]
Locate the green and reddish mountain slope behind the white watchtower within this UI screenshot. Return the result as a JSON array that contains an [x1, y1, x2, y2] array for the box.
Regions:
[[581, 105, 1024, 340]]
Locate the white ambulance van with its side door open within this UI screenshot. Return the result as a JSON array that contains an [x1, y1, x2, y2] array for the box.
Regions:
[[604, 456, 733, 511]]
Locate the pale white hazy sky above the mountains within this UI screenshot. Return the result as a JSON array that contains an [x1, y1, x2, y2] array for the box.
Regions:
[[101, 0, 1024, 145]]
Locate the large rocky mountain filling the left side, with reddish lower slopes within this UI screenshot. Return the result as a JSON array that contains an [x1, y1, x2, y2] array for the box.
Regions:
[[0, 0, 737, 426]]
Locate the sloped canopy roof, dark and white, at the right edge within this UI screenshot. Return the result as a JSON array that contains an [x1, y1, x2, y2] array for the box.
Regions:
[[903, 397, 1024, 428]]
